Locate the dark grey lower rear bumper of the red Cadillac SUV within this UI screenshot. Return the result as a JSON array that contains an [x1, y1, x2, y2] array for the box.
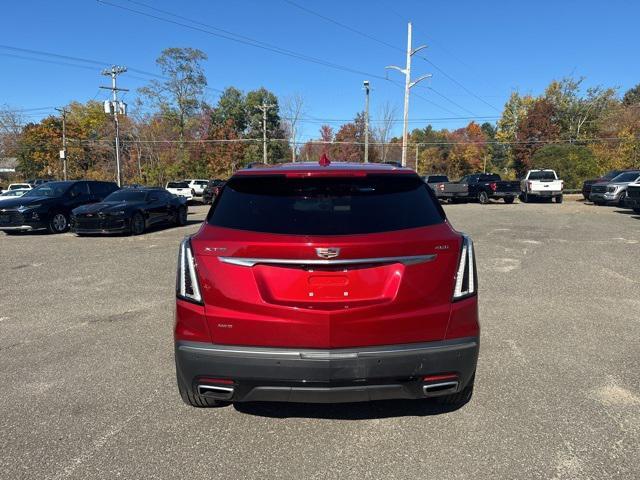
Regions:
[[175, 337, 479, 403]]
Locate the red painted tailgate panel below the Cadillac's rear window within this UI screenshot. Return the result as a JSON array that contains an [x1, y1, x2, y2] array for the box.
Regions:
[[185, 223, 476, 348]]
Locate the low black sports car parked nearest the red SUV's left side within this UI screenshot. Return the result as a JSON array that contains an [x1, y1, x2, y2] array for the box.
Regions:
[[71, 188, 188, 235]]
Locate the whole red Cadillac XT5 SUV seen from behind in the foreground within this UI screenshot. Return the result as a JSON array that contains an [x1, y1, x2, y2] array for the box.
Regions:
[[174, 160, 479, 407]]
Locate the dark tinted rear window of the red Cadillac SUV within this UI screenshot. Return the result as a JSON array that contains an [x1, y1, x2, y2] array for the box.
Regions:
[[209, 175, 444, 235]]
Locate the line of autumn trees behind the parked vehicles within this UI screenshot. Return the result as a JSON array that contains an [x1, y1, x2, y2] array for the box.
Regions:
[[0, 48, 640, 188]]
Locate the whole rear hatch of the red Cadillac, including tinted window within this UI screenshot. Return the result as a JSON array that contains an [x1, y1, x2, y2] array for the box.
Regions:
[[192, 176, 460, 348]]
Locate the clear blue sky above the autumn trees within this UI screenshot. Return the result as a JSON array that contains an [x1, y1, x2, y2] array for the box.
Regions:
[[0, 0, 640, 138]]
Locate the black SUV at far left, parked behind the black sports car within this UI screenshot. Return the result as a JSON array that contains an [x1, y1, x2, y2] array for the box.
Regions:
[[0, 180, 118, 233]]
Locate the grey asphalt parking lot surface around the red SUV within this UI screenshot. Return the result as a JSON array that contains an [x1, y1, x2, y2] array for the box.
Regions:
[[0, 201, 640, 479]]
